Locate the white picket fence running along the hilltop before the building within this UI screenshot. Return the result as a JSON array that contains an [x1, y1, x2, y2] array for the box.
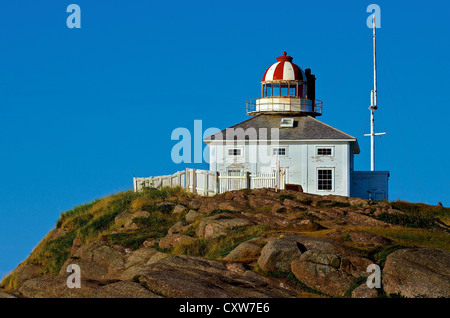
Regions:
[[133, 168, 285, 196]]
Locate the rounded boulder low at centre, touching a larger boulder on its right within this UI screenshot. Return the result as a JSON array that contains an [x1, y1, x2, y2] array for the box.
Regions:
[[258, 239, 302, 272]]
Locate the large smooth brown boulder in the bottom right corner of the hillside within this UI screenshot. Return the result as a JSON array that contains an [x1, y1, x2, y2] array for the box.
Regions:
[[382, 247, 450, 298]]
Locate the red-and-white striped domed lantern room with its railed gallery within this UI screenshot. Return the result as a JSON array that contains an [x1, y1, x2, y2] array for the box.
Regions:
[[246, 52, 322, 117]]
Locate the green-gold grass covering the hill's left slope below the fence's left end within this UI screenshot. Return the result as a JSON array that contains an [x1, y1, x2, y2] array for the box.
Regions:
[[19, 188, 186, 274]]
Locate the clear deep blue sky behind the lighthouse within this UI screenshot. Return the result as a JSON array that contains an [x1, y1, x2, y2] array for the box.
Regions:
[[0, 0, 450, 276]]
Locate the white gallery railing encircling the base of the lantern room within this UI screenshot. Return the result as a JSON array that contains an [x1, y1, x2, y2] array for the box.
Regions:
[[245, 97, 323, 115]]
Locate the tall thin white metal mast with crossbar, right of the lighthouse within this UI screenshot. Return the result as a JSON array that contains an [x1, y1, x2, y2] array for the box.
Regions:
[[364, 15, 386, 171]]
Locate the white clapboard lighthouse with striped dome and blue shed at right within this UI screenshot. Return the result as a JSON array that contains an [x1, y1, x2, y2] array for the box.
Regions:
[[204, 52, 389, 200]]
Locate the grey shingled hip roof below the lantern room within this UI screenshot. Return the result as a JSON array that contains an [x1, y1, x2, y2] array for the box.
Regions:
[[204, 114, 356, 142]]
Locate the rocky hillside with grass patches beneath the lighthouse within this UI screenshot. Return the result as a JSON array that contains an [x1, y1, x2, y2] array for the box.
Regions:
[[0, 188, 450, 297]]
